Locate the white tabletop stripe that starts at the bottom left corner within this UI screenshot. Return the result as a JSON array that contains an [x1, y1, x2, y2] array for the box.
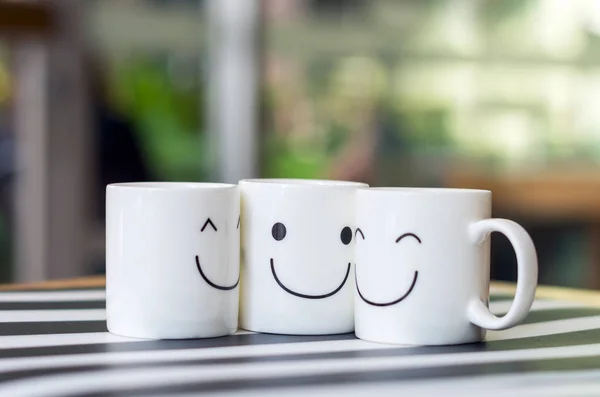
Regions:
[[0, 344, 600, 397]]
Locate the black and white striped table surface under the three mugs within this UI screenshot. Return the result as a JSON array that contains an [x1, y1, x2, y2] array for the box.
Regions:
[[0, 283, 600, 397]]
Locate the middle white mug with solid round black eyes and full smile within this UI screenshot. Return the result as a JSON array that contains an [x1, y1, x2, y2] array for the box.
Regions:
[[239, 179, 367, 335]]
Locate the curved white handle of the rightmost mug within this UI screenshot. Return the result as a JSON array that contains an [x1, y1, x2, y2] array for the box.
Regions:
[[467, 219, 538, 330]]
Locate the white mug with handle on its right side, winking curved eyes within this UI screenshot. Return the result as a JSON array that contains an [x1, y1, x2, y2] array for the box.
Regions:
[[355, 188, 538, 345]]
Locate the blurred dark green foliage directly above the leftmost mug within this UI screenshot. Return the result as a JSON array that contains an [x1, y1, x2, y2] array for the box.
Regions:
[[114, 59, 208, 181]]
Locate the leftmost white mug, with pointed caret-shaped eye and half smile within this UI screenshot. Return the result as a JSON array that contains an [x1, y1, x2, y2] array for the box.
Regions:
[[106, 182, 240, 339]]
